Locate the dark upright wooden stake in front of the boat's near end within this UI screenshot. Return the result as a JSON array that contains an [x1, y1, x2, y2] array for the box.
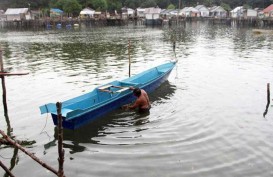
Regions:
[[56, 102, 64, 177]]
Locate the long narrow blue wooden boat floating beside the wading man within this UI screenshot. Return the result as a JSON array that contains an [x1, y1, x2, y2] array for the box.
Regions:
[[40, 62, 176, 129]]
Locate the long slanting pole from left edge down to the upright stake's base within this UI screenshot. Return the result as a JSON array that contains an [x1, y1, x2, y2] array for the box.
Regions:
[[0, 130, 58, 175]]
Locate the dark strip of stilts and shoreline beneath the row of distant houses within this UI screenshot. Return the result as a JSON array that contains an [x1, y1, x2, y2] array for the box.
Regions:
[[0, 17, 273, 30]]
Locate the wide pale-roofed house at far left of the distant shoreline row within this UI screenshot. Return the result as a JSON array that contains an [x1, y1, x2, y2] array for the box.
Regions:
[[4, 8, 31, 21]]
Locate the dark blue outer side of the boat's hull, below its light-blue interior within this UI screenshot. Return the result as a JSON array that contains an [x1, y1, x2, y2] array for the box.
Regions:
[[51, 70, 171, 129]]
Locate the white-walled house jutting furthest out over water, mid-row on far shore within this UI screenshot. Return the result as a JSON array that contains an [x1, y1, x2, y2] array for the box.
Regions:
[[144, 7, 162, 25]]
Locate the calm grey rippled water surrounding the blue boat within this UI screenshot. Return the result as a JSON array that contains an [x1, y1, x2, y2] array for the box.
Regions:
[[0, 23, 273, 177]]
